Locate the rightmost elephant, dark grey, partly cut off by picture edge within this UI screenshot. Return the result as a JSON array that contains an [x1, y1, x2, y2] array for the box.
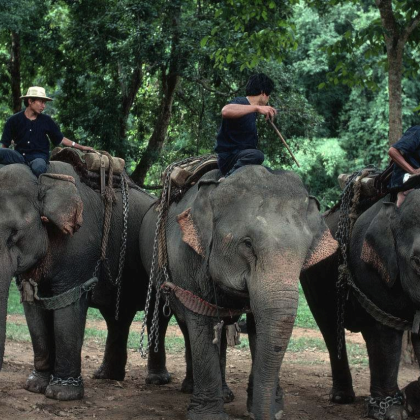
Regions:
[[301, 190, 420, 420]]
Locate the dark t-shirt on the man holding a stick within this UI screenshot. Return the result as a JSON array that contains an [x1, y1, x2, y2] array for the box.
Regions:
[[214, 97, 258, 153]]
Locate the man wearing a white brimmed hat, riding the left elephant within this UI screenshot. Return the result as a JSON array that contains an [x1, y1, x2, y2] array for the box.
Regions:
[[0, 86, 93, 177]]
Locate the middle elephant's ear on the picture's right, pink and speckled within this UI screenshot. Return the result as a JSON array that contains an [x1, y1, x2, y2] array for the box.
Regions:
[[302, 196, 338, 271]]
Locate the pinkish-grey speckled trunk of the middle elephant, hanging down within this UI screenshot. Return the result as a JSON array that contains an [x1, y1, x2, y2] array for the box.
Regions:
[[250, 253, 301, 420]]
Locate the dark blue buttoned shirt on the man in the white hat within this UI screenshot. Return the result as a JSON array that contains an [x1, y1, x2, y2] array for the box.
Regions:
[[1, 111, 64, 161]]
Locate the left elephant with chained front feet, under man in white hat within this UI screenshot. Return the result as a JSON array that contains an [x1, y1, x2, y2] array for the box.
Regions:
[[0, 161, 170, 400]]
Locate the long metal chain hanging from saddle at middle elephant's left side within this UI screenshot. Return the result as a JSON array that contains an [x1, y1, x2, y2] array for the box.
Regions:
[[139, 155, 213, 358]]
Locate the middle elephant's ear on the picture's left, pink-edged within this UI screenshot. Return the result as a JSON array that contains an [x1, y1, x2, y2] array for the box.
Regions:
[[177, 183, 216, 258]]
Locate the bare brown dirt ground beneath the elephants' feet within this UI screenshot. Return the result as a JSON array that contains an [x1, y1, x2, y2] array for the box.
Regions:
[[0, 317, 419, 420]]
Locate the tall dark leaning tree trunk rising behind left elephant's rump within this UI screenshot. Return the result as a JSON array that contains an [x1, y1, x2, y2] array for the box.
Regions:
[[131, 2, 181, 185]]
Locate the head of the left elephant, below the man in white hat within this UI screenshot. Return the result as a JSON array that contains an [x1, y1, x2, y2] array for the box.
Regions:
[[0, 164, 83, 369]]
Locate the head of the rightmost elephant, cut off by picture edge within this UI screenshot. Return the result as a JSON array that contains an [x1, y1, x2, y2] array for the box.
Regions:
[[360, 190, 420, 310]]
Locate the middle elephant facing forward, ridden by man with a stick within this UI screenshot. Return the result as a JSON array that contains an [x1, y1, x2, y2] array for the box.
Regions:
[[140, 165, 337, 420]]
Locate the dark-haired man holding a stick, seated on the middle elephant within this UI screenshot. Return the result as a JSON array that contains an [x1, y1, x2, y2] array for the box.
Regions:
[[215, 73, 277, 176]]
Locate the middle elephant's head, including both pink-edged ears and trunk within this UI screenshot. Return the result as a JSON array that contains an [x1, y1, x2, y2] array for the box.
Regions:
[[178, 166, 337, 418]]
